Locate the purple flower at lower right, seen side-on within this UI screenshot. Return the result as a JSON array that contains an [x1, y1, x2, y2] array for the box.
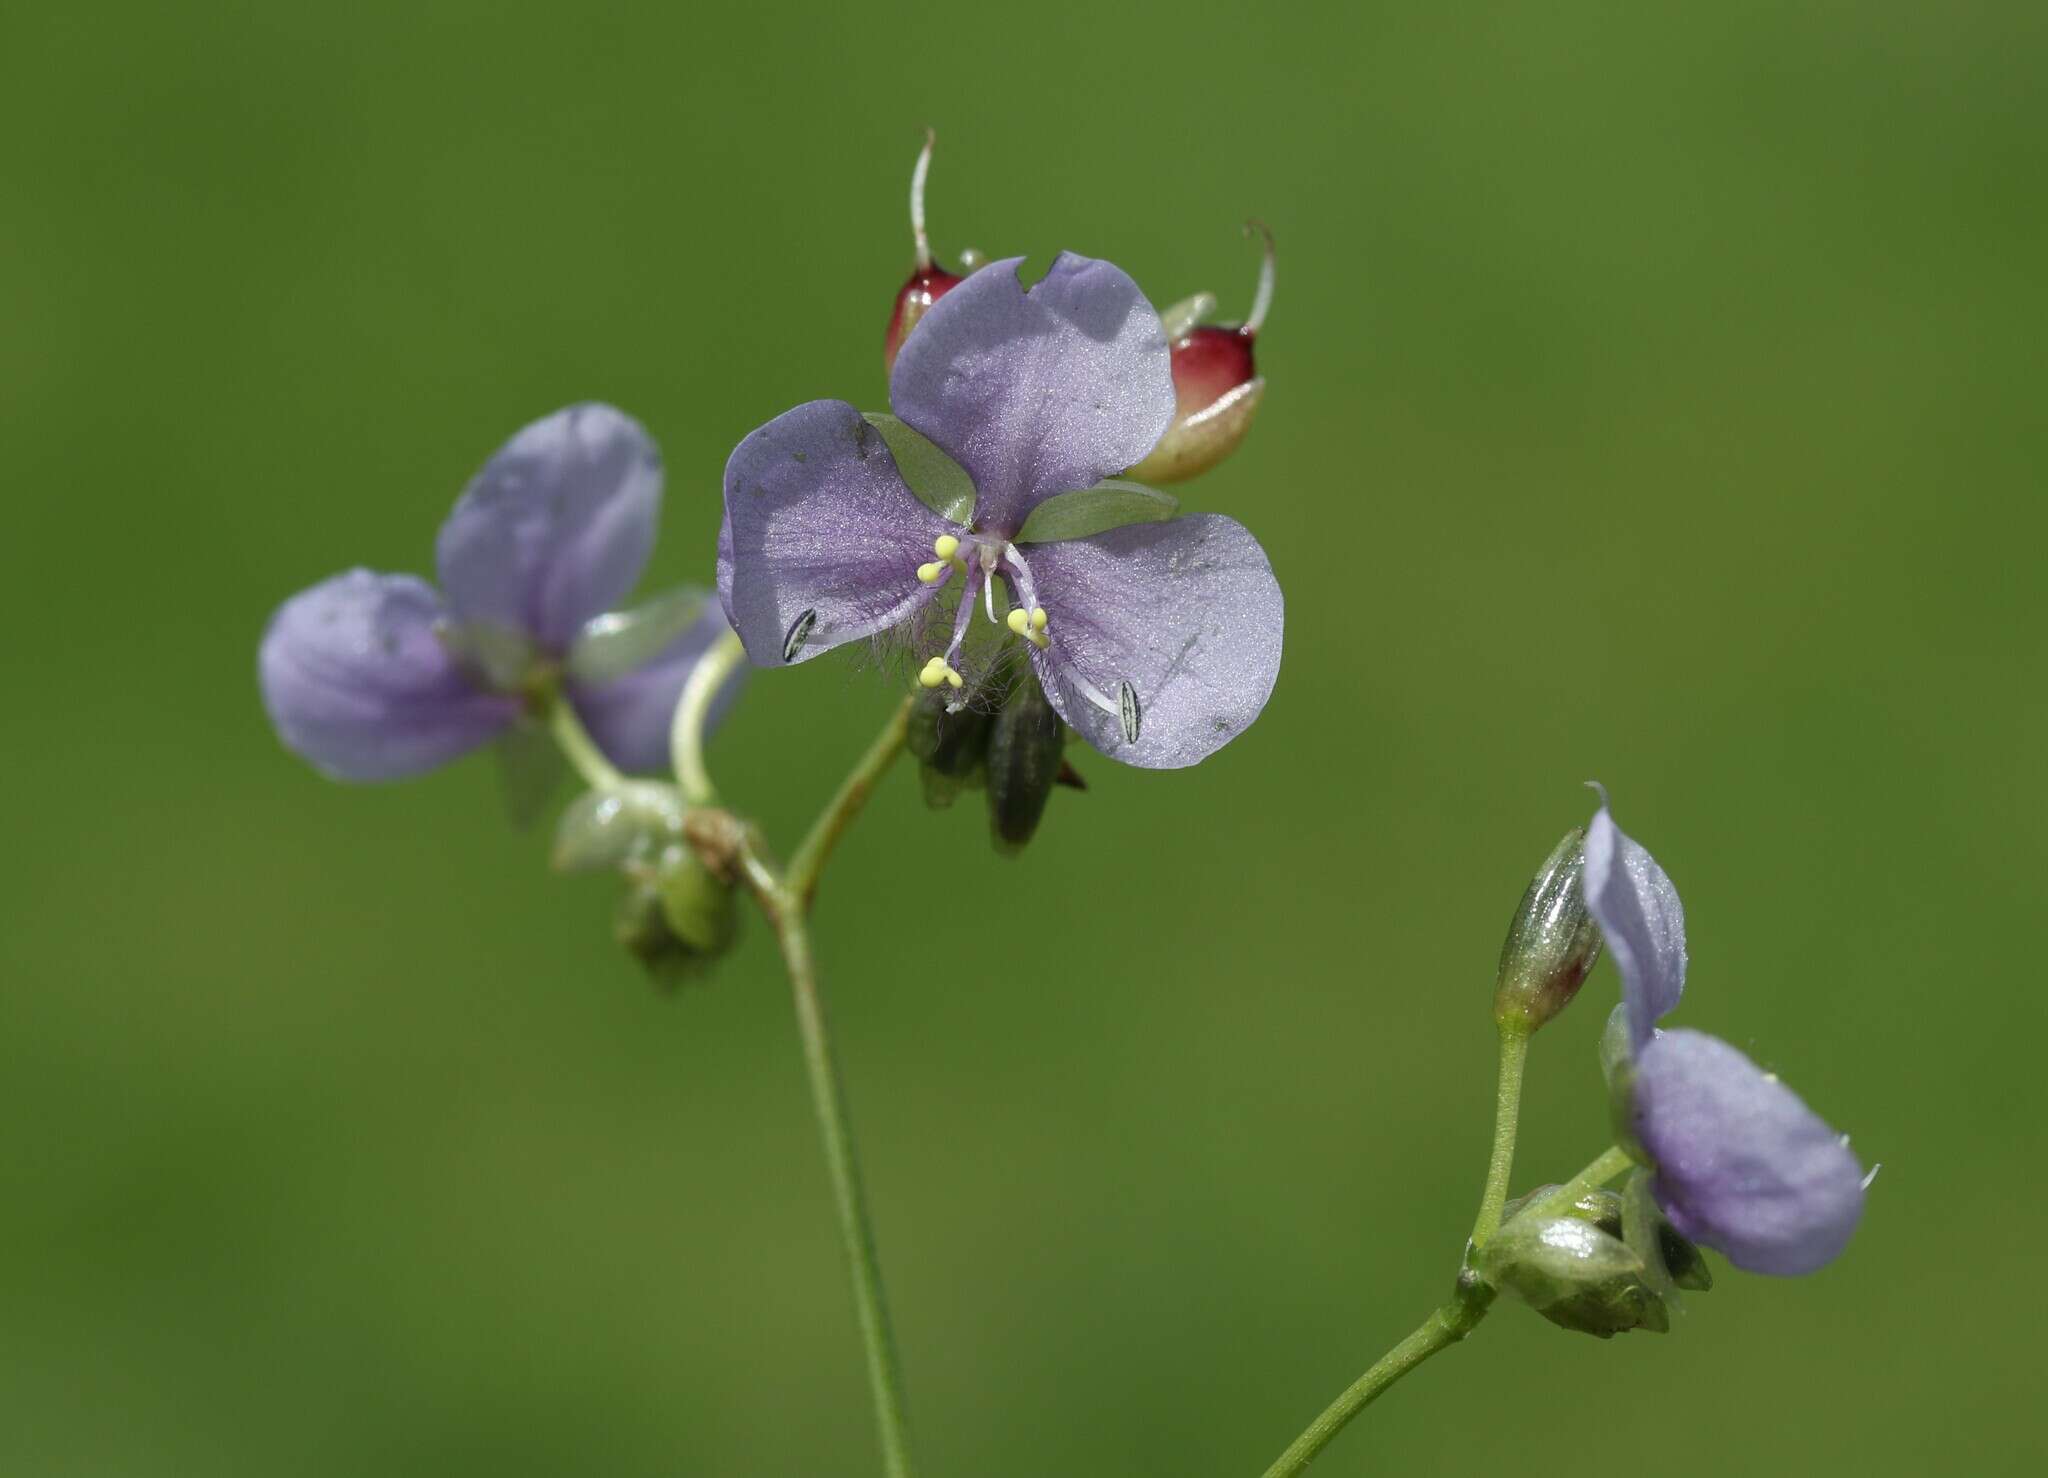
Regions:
[[1585, 794, 1868, 1275]]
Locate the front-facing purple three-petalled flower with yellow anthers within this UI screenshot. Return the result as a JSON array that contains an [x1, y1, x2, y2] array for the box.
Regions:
[[719, 254, 1282, 770]]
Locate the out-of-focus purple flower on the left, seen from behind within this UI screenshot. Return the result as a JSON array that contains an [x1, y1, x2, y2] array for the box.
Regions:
[[256, 405, 725, 780]]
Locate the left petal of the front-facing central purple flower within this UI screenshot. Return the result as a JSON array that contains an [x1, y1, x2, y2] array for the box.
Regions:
[[719, 401, 954, 665]]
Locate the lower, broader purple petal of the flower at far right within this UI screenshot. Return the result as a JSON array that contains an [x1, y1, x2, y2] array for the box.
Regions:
[[1634, 1030, 1864, 1277]]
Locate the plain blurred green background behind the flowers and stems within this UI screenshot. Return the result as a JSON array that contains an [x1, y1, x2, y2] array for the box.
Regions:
[[0, 0, 2048, 1478]]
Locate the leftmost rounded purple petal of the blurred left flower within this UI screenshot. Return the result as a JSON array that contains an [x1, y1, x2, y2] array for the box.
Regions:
[[256, 569, 518, 780]]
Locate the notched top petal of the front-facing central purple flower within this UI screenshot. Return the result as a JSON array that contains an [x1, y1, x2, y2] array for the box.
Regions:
[[889, 252, 1174, 538]]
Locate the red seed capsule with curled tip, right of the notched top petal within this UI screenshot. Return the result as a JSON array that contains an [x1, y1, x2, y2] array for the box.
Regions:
[[1130, 221, 1274, 483]]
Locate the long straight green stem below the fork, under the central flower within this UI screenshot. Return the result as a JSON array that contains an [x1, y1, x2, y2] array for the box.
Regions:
[[774, 884, 909, 1478]]
